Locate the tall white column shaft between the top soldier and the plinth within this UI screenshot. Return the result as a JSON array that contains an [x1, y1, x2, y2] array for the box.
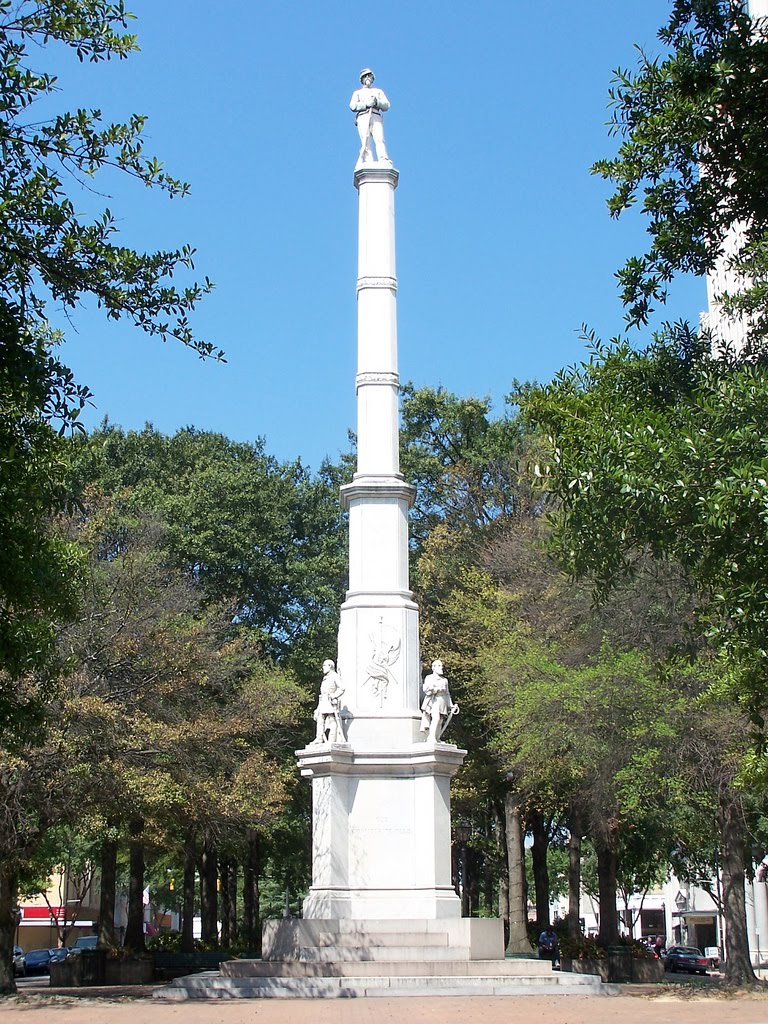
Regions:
[[339, 165, 421, 748]]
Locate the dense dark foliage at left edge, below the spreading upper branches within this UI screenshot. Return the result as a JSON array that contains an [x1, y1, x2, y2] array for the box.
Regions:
[[0, 299, 84, 734]]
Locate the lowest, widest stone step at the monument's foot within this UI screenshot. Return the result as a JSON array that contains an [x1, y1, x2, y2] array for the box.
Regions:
[[154, 972, 620, 1000]]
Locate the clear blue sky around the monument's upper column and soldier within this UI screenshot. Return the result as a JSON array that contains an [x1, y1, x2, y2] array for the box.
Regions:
[[40, 0, 705, 468]]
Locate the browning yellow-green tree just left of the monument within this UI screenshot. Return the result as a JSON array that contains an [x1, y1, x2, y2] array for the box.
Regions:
[[54, 494, 305, 948]]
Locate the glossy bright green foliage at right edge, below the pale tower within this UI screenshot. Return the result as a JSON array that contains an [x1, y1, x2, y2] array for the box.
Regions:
[[521, 326, 768, 723]]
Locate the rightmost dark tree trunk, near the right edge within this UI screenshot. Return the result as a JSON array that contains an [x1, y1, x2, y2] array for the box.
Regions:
[[718, 791, 758, 985]]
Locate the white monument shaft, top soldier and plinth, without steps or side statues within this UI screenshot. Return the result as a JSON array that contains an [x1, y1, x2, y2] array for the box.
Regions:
[[297, 75, 466, 930]]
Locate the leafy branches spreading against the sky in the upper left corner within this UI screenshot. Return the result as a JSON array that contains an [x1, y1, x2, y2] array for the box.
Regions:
[[0, 0, 221, 355]]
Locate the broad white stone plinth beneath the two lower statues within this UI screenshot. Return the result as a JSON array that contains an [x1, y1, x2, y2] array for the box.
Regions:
[[297, 743, 466, 921]]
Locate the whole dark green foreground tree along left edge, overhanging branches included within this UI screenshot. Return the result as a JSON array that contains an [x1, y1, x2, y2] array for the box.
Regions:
[[0, 0, 215, 749]]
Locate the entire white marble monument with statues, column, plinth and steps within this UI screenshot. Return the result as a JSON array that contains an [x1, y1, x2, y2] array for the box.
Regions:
[[158, 69, 614, 999]]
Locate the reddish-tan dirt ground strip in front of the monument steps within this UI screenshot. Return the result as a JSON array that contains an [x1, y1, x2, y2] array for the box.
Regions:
[[0, 992, 768, 1024]]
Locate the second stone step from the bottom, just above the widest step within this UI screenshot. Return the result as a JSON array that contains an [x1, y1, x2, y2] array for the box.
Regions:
[[221, 956, 553, 978]]
